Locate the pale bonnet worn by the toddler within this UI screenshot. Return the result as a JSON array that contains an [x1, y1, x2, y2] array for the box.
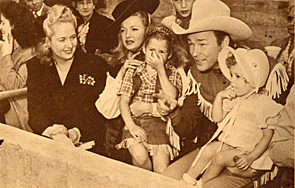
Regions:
[[218, 47, 269, 91]]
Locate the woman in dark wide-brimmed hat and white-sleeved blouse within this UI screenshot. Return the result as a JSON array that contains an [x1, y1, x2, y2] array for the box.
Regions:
[[96, 0, 159, 162]]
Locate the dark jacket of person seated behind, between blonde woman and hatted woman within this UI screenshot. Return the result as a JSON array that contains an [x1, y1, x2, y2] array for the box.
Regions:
[[85, 11, 117, 54]]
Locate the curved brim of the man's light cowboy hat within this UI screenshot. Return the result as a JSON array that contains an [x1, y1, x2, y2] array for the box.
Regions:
[[172, 16, 252, 40]]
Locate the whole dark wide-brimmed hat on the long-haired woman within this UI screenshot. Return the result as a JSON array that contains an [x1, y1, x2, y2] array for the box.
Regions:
[[108, 0, 160, 32]]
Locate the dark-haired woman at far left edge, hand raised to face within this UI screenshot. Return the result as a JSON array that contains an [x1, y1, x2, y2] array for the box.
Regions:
[[0, 1, 42, 131]]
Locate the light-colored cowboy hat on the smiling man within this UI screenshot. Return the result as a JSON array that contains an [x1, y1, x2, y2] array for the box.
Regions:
[[172, 0, 252, 40]]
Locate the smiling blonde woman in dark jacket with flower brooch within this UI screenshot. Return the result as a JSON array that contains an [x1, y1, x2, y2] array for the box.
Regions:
[[27, 5, 107, 154]]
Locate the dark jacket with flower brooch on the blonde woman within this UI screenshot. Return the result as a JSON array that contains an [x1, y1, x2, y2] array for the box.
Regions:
[[27, 50, 107, 153]]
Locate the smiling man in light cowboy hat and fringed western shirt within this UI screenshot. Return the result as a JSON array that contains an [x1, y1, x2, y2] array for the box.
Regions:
[[150, 0, 252, 187]]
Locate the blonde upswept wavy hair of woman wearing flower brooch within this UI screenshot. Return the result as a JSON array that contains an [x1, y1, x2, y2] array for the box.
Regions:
[[37, 5, 77, 65]]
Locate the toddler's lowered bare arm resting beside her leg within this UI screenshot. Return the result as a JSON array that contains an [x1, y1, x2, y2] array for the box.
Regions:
[[236, 129, 274, 170]]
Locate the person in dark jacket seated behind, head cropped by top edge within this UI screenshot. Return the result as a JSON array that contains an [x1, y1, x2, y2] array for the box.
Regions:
[[73, 0, 117, 54]]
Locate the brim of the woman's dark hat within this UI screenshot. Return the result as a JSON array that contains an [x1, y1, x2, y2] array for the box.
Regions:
[[107, 0, 160, 32]]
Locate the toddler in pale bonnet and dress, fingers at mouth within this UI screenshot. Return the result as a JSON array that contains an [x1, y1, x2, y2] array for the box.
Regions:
[[183, 47, 282, 187]]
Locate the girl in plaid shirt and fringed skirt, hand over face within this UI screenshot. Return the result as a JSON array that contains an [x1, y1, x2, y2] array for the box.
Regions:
[[117, 26, 185, 173]]
